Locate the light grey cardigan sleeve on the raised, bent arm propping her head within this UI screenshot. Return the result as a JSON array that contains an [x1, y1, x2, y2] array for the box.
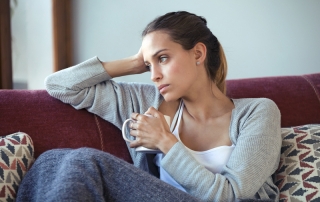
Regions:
[[45, 57, 161, 128]]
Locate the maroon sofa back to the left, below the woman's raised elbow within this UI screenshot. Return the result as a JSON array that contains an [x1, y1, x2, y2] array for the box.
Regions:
[[0, 90, 131, 162]]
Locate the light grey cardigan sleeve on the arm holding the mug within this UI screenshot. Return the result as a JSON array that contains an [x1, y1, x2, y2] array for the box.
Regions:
[[161, 99, 281, 201]]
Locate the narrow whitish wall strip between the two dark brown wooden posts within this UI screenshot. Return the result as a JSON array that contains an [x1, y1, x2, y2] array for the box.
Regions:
[[11, 0, 53, 89]]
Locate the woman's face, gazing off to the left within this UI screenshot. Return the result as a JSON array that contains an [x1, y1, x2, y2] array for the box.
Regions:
[[141, 31, 198, 101]]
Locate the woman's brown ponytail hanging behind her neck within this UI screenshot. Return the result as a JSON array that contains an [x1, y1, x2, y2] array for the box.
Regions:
[[214, 42, 228, 94]]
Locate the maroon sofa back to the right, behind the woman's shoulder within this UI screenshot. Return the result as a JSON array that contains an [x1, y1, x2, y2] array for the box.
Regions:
[[227, 73, 320, 127]]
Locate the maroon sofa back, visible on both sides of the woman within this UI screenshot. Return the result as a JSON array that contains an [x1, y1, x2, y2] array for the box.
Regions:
[[0, 73, 320, 162]]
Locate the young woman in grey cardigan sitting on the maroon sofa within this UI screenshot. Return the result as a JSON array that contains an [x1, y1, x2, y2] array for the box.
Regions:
[[18, 12, 281, 201]]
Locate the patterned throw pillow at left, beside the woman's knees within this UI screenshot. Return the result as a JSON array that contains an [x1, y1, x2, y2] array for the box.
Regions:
[[0, 132, 34, 201]]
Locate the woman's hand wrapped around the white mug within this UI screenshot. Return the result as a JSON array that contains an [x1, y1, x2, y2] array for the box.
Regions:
[[130, 107, 178, 154]]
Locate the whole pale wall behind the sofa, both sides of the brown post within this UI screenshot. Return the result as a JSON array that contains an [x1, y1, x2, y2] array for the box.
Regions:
[[11, 0, 320, 89]]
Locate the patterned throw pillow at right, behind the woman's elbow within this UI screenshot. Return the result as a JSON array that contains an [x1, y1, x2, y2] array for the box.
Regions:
[[275, 125, 320, 202]]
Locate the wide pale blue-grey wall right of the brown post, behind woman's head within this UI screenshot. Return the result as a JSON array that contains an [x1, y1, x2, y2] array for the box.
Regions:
[[73, 0, 320, 83]]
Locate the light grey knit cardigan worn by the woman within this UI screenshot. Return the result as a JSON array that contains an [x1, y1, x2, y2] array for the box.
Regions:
[[45, 57, 281, 201]]
